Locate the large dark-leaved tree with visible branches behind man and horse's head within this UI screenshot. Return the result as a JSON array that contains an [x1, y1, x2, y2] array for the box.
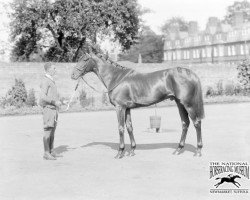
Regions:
[[11, 0, 141, 61]]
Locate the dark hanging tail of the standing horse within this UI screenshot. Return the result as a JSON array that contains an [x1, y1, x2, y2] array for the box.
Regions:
[[193, 77, 205, 120]]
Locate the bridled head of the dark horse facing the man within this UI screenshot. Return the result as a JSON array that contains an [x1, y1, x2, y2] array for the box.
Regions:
[[71, 54, 95, 80]]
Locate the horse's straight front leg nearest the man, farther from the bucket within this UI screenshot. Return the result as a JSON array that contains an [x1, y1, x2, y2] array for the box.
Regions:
[[115, 106, 126, 158]]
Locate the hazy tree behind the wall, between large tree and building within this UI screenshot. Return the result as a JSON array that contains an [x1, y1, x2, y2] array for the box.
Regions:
[[119, 26, 163, 63]]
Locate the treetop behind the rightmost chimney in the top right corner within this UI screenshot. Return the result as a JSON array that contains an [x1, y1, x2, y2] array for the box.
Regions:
[[223, 1, 250, 24]]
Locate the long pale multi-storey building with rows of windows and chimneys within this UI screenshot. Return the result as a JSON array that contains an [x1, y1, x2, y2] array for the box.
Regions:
[[163, 12, 250, 64]]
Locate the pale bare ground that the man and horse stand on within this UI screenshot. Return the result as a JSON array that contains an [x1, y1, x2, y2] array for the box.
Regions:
[[0, 103, 250, 200]]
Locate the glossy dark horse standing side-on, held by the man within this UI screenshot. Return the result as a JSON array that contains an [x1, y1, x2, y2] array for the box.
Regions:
[[71, 53, 204, 158]]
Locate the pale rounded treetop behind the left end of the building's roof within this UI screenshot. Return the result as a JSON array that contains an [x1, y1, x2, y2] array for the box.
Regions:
[[161, 17, 188, 35]]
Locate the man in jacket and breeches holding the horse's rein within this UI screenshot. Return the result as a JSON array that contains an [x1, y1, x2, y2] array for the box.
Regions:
[[39, 63, 61, 160]]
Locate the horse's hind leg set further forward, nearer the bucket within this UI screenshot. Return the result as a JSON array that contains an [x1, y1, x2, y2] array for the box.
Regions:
[[173, 100, 190, 155]]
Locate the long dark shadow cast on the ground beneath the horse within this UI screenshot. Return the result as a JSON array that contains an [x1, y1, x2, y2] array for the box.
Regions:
[[81, 142, 196, 154]]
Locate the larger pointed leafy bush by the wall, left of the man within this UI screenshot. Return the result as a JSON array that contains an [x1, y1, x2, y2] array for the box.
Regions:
[[5, 79, 27, 108]]
